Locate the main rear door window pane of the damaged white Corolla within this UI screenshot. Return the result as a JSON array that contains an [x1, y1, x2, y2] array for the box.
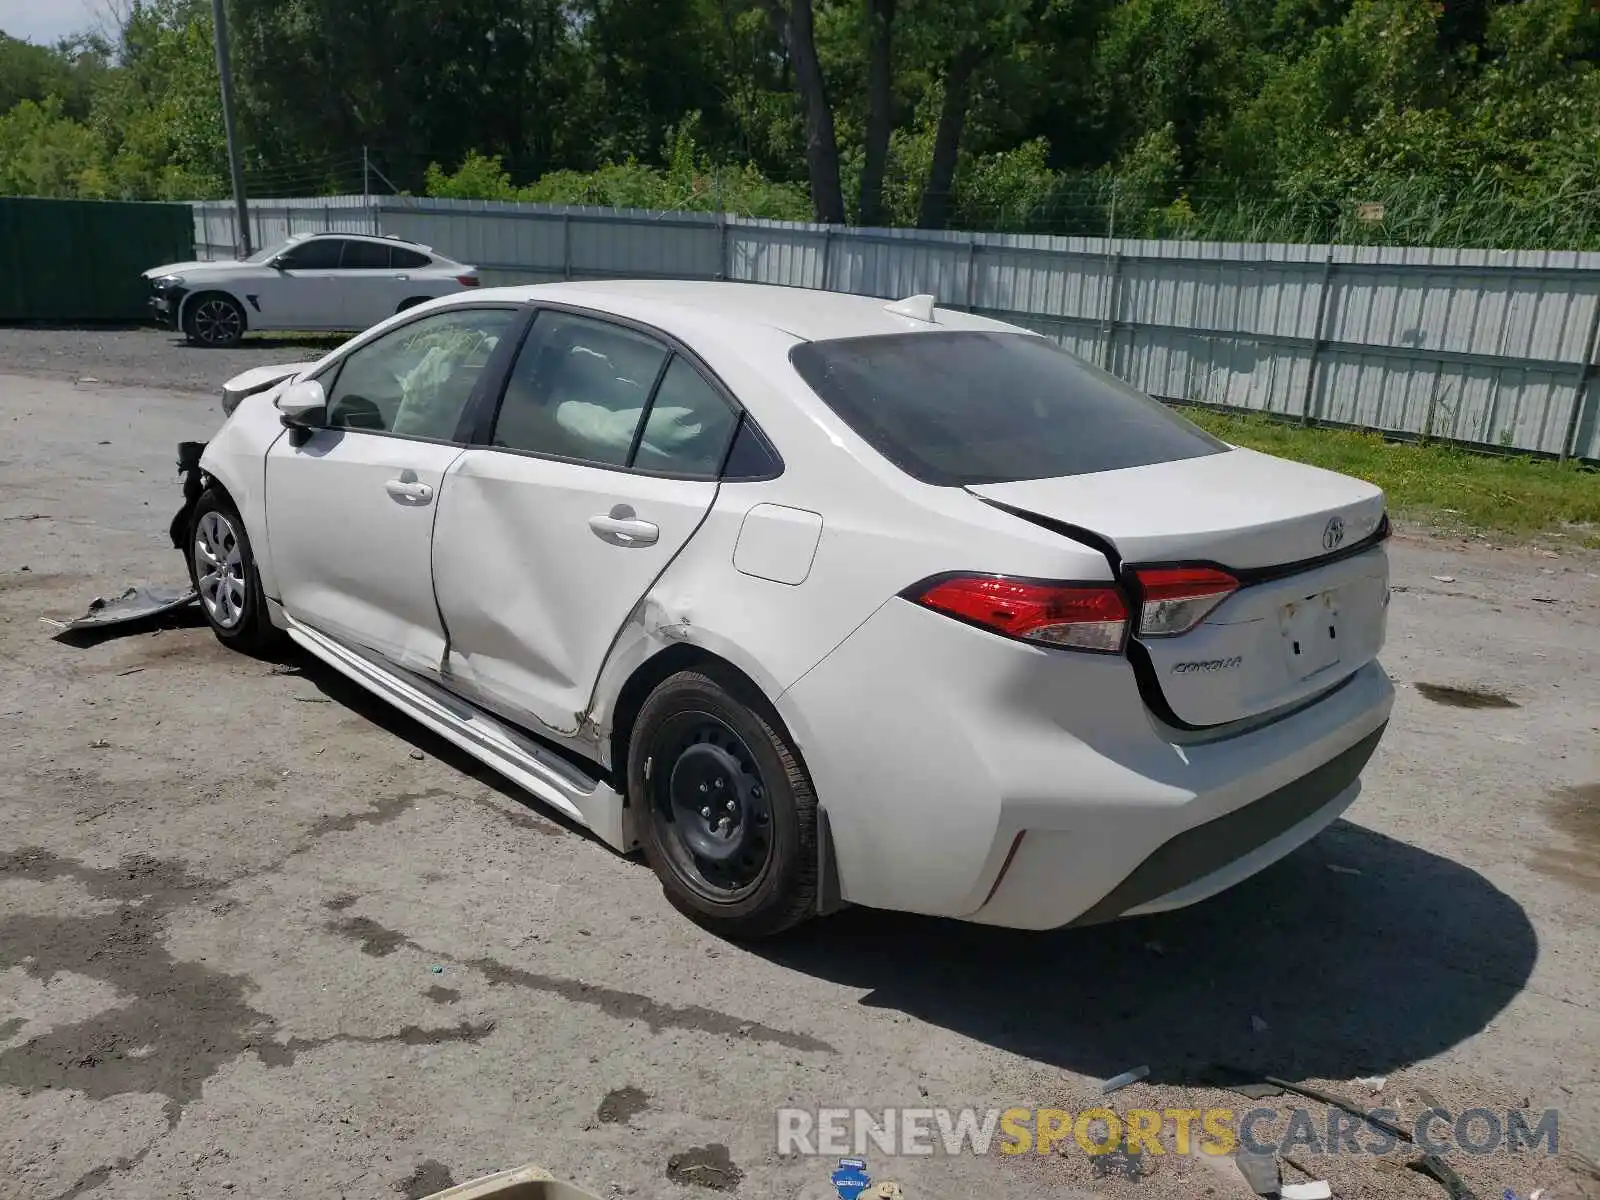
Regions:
[[490, 310, 667, 467]]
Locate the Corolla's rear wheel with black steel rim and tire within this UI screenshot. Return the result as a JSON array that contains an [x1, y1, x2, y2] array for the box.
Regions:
[[627, 670, 818, 941]]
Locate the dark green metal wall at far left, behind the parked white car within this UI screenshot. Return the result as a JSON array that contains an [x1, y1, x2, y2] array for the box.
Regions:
[[0, 197, 195, 322]]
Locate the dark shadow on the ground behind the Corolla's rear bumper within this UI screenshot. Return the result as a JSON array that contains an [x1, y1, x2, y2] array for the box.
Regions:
[[754, 821, 1538, 1083]]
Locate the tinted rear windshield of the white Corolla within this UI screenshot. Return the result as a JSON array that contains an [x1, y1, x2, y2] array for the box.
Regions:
[[789, 331, 1227, 486]]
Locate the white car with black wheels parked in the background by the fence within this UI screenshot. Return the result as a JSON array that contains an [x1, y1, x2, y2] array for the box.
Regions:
[[144, 234, 480, 346]]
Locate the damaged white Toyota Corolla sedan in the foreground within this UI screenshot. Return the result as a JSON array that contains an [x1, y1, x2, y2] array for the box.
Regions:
[[173, 282, 1394, 938]]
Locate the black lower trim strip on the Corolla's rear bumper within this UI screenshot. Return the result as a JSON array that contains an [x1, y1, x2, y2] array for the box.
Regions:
[[1070, 722, 1389, 926]]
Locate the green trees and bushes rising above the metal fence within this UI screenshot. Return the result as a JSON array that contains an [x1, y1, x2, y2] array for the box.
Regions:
[[0, 0, 1600, 248]]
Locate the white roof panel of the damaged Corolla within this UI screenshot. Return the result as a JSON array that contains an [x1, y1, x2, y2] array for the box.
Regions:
[[459, 280, 1018, 350]]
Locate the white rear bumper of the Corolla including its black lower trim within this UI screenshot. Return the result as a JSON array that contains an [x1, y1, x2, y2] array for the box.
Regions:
[[779, 602, 1394, 930]]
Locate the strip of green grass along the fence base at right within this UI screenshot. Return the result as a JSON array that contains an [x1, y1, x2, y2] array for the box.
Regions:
[[1182, 406, 1600, 547]]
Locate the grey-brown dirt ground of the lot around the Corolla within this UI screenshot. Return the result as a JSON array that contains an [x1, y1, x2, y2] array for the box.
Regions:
[[0, 330, 1600, 1200]]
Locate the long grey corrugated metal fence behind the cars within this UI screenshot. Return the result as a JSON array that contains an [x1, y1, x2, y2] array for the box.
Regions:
[[181, 197, 1600, 459]]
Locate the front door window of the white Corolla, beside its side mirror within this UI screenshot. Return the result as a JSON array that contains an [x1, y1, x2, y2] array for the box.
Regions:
[[323, 309, 517, 442]]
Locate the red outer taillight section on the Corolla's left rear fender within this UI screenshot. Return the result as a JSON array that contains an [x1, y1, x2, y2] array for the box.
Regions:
[[917, 574, 1128, 653]]
